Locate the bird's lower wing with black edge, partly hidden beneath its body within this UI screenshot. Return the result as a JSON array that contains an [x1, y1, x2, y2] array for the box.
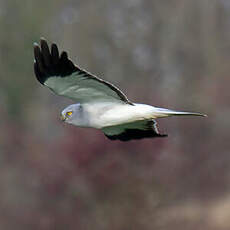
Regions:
[[102, 120, 167, 141]]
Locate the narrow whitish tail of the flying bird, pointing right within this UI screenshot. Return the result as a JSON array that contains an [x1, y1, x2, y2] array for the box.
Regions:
[[154, 107, 207, 118]]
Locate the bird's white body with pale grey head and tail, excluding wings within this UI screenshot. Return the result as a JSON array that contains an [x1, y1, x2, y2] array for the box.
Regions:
[[62, 102, 204, 129]]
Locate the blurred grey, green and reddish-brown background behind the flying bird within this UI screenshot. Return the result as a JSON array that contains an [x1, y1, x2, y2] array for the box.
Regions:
[[0, 0, 230, 230]]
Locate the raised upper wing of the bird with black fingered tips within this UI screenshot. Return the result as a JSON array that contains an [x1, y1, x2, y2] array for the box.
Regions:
[[34, 39, 132, 104]]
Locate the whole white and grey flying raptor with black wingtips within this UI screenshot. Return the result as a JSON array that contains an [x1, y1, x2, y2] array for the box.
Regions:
[[34, 38, 206, 141]]
